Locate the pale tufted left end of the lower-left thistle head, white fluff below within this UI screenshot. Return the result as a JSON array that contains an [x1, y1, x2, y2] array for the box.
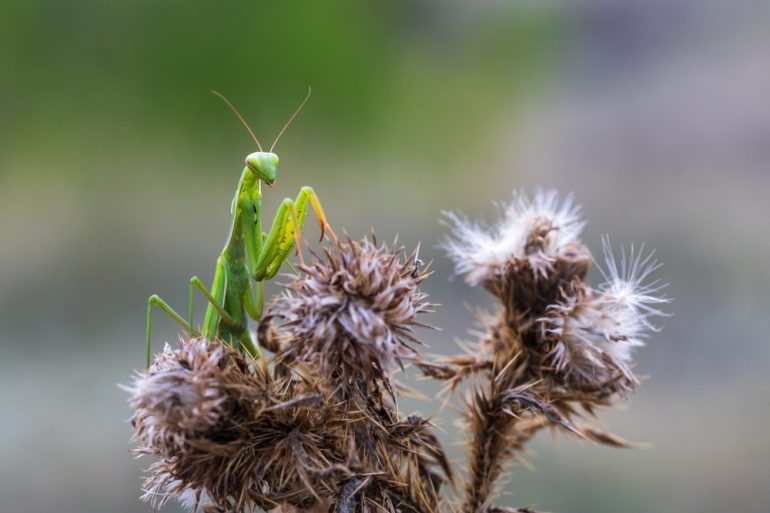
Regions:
[[129, 338, 246, 511]]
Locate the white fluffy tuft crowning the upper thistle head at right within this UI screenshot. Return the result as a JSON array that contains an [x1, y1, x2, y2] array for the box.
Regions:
[[444, 190, 590, 285]]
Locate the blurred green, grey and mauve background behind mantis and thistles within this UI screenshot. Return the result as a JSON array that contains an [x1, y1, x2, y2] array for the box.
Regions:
[[0, 0, 770, 513]]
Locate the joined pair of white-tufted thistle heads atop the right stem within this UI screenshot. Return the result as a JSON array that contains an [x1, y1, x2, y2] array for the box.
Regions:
[[446, 191, 667, 402]]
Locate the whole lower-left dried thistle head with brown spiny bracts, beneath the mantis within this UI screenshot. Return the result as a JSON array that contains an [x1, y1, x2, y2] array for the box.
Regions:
[[131, 338, 345, 511]]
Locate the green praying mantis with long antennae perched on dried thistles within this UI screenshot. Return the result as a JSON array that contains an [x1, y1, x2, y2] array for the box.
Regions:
[[147, 89, 337, 367]]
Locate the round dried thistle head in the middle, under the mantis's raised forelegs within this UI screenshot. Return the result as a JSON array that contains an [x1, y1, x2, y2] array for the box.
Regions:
[[268, 239, 431, 377]]
